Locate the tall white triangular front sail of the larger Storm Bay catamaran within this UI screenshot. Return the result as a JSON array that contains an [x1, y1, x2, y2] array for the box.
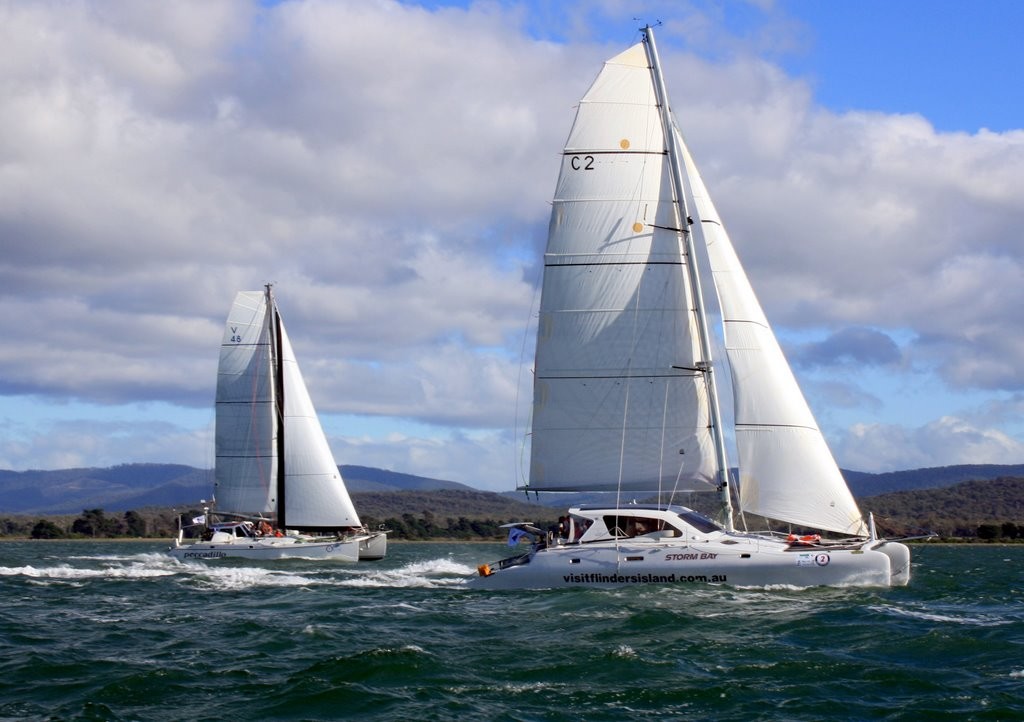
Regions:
[[677, 139, 867, 536]]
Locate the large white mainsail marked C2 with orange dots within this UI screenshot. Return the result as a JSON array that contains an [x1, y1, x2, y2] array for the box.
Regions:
[[528, 45, 716, 491]]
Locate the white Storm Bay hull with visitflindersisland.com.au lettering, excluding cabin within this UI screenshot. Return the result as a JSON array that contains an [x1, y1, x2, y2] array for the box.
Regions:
[[469, 539, 910, 590]]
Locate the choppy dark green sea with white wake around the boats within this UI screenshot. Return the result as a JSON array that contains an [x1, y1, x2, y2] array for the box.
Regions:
[[0, 542, 1024, 722]]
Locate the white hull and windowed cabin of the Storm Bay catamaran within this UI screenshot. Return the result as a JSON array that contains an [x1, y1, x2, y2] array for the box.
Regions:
[[469, 505, 910, 589]]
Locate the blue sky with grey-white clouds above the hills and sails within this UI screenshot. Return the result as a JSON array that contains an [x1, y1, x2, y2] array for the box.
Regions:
[[0, 0, 1024, 491]]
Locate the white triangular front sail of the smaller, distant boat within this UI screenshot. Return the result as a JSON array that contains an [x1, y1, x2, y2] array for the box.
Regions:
[[281, 324, 361, 529]]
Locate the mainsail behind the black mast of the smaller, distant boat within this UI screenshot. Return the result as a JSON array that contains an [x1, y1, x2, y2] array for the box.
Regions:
[[214, 291, 278, 513]]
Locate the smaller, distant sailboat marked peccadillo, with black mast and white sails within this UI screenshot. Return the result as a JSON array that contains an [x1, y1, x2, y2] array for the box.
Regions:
[[168, 284, 387, 561]]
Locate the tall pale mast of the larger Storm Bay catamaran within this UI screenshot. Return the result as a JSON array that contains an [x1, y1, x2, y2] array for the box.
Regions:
[[643, 26, 734, 532]]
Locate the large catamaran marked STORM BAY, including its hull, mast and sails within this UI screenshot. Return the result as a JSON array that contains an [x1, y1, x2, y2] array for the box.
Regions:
[[468, 27, 910, 589]]
